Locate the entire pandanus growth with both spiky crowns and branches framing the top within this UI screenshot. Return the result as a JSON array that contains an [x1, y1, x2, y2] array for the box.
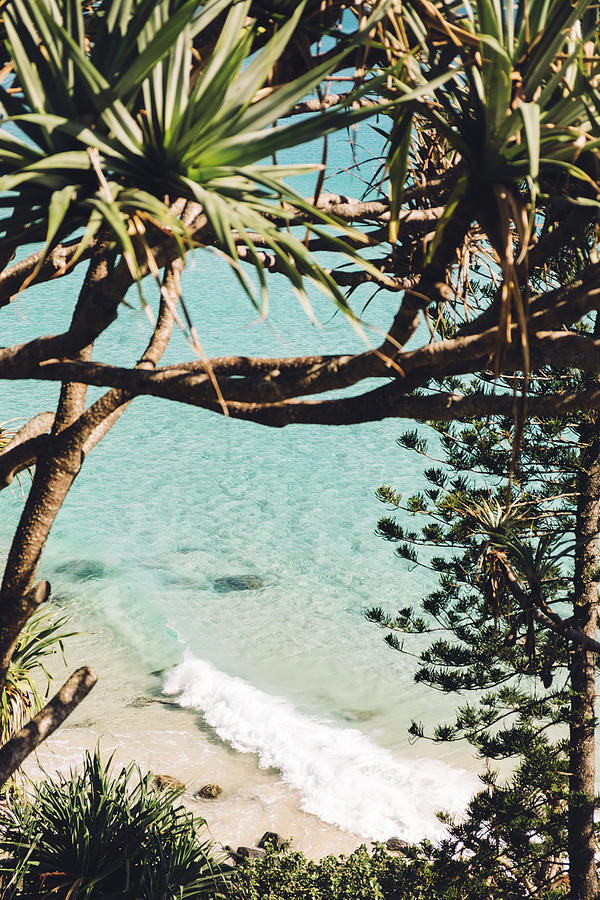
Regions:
[[0, 0, 600, 888]]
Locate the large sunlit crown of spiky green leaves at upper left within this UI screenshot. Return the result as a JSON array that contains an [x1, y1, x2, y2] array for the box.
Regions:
[[0, 0, 394, 316]]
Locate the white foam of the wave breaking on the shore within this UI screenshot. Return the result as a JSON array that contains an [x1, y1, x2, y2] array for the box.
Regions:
[[164, 655, 476, 841]]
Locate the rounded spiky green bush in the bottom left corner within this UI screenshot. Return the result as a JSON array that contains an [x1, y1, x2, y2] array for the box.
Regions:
[[0, 751, 226, 900]]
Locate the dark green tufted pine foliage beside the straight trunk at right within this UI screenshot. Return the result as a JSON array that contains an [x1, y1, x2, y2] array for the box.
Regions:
[[367, 356, 598, 888]]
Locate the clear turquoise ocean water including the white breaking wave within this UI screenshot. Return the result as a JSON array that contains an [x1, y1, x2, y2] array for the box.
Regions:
[[0, 137, 472, 838]]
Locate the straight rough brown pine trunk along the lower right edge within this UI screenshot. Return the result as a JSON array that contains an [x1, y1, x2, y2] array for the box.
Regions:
[[569, 417, 600, 900]]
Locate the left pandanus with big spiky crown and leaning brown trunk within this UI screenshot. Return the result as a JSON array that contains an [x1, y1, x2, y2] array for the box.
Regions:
[[0, 0, 400, 778]]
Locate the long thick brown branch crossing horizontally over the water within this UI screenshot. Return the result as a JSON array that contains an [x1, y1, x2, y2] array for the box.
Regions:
[[9, 325, 600, 404]]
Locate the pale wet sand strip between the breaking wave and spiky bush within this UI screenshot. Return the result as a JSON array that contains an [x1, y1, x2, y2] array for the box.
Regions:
[[25, 638, 368, 859]]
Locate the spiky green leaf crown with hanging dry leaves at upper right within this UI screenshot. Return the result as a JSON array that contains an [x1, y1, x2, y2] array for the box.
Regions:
[[389, 0, 600, 253]]
